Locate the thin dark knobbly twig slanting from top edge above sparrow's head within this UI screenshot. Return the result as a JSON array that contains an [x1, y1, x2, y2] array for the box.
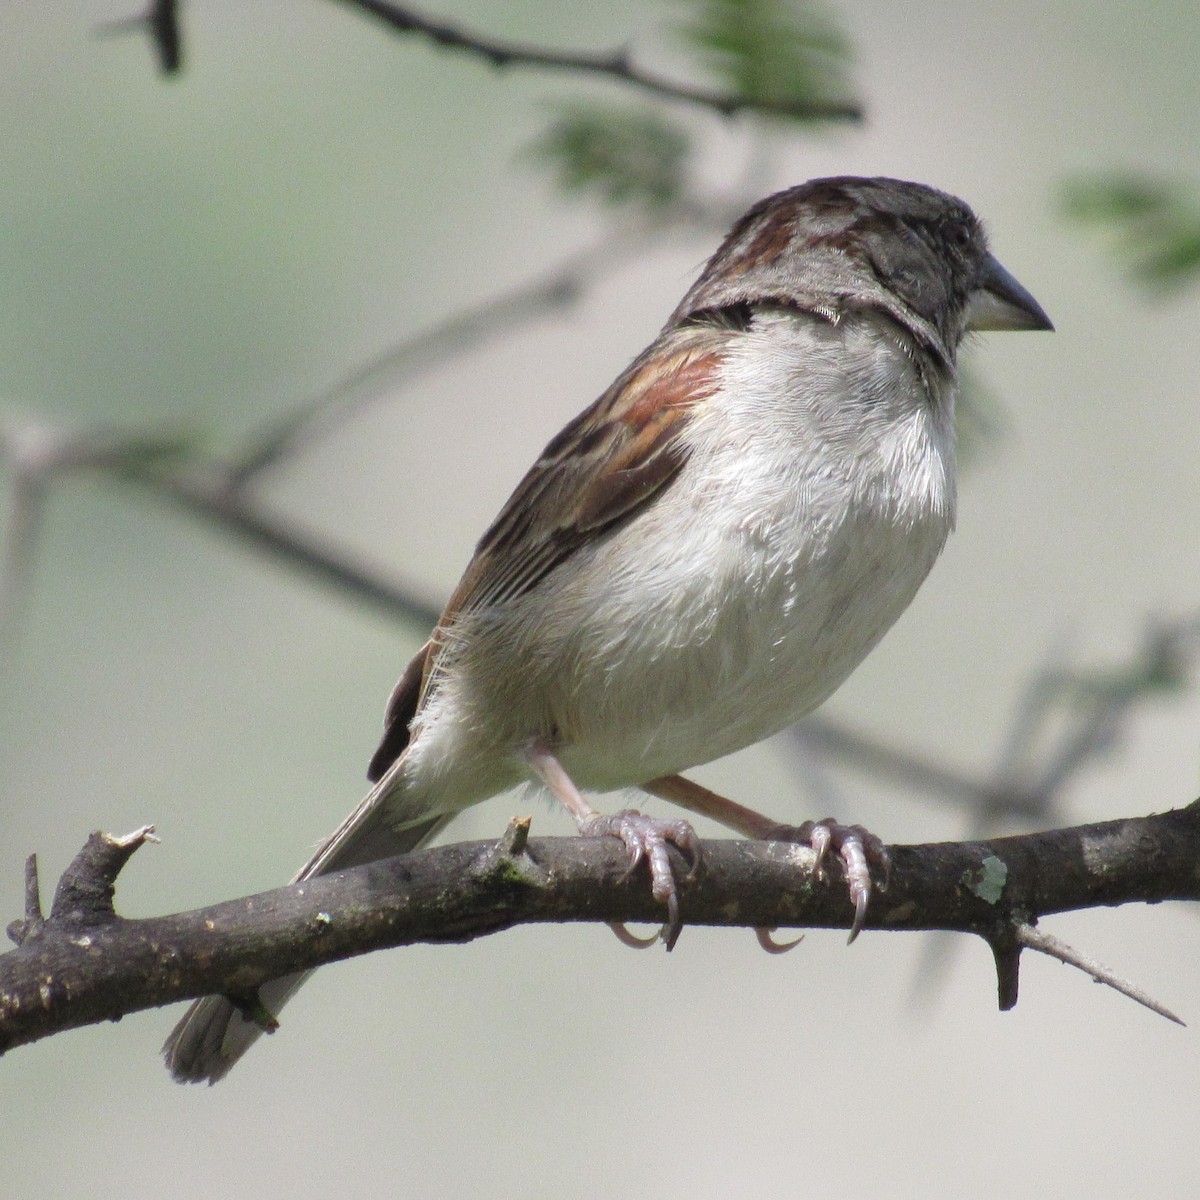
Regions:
[[324, 0, 863, 121]]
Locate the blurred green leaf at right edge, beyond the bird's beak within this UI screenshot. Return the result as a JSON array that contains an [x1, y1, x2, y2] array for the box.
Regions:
[[1063, 174, 1200, 288]]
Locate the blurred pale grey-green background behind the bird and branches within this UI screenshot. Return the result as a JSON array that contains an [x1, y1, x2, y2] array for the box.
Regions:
[[0, 0, 1200, 1198]]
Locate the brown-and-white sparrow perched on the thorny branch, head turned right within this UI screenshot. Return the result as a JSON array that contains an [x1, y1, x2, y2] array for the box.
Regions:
[[163, 176, 1052, 1082]]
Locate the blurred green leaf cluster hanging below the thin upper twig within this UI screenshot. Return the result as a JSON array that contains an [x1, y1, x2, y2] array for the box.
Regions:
[[529, 104, 691, 211]]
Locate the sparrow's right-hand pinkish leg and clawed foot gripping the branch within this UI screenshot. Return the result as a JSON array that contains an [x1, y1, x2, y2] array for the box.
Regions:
[[642, 775, 892, 941]]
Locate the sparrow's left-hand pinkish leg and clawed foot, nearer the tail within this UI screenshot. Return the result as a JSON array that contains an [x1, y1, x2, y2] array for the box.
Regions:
[[526, 742, 700, 950]]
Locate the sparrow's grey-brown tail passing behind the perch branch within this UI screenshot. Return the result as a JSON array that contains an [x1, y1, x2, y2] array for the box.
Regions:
[[162, 772, 450, 1084]]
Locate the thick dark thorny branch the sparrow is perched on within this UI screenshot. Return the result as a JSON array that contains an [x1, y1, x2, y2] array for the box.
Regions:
[[0, 800, 1200, 1051]]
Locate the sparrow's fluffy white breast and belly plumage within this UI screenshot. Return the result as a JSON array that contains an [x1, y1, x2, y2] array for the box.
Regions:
[[403, 310, 954, 803]]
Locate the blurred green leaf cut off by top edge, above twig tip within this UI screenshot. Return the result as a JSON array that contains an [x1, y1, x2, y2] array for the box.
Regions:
[[682, 0, 851, 117]]
